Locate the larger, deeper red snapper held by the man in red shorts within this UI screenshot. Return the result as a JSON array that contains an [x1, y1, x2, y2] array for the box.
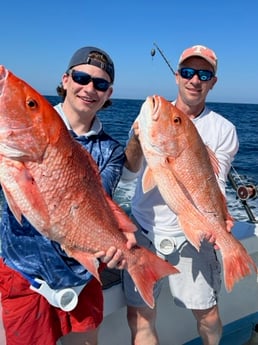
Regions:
[[0, 66, 178, 307]]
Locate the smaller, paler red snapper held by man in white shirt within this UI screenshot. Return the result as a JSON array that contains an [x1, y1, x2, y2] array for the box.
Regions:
[[135, 96, 257, 291]]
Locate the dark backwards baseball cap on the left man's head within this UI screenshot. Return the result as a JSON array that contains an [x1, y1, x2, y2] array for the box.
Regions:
[[67, 47, 115, 83]]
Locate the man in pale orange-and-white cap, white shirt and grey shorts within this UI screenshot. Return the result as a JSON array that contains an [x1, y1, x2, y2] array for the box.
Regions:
[[124, 45, 238, 345]]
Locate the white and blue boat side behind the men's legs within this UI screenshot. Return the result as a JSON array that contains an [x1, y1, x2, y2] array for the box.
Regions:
[[99, 222, 258, 345]]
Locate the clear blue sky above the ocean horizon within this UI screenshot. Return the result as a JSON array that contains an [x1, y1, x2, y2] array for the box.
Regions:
[[0, 0, 258, 103]]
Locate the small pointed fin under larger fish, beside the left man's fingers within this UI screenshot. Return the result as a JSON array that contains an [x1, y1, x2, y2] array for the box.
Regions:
[[64, 248, 101, 283]]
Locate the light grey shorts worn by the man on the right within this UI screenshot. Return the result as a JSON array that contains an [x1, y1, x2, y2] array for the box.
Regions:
[[122, 230, 221, 309]]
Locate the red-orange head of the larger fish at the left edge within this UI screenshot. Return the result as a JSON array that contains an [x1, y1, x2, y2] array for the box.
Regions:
[[0, 65, 62, 161]]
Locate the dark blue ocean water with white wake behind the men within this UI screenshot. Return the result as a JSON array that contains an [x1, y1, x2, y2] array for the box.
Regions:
[[46, 96, 258, 220]]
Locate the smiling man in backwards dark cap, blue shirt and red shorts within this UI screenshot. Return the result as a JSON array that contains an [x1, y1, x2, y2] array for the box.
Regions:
[[0, 47, 135, 345]]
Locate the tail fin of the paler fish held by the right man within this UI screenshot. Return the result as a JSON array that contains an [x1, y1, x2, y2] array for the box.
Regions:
[[222, 240, 258, 292]]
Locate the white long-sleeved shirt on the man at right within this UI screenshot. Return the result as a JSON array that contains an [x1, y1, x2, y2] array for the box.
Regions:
[[124, 107, 239, 236]]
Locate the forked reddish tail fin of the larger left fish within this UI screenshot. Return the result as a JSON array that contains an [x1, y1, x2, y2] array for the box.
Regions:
[[128, 247, 179, 308]]
